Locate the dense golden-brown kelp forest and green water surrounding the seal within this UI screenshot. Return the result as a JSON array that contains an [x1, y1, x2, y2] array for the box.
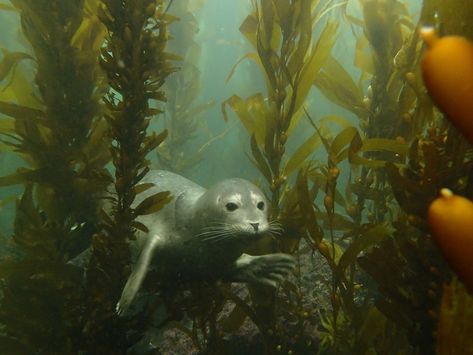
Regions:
[[0, 0, 473, 355]]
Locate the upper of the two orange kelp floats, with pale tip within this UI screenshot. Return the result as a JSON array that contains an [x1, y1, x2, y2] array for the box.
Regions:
[[420, 27, 473, 143]]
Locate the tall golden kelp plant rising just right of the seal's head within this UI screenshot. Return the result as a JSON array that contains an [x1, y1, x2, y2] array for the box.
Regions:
[[222, 0, 337, 352]]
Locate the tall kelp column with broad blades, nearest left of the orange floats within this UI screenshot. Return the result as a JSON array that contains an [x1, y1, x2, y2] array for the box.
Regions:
[[315, 1, 440, 353]]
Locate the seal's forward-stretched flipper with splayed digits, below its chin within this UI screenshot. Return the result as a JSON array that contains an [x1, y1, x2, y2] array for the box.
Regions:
[[232, 253, 295, 287]]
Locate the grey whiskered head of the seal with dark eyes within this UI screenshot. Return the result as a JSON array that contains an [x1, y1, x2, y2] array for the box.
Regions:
[[190, 179, 276, 241]]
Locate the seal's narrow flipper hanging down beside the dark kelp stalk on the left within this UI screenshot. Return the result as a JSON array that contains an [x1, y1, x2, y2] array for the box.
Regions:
[[115, 234, 161, 315]]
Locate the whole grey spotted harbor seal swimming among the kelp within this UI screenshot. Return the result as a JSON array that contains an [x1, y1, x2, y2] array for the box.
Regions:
[[116, 170, 295, 315]]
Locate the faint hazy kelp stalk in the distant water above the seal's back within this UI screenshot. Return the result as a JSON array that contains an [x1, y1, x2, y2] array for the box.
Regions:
[[158, 0, 213, 173]]
